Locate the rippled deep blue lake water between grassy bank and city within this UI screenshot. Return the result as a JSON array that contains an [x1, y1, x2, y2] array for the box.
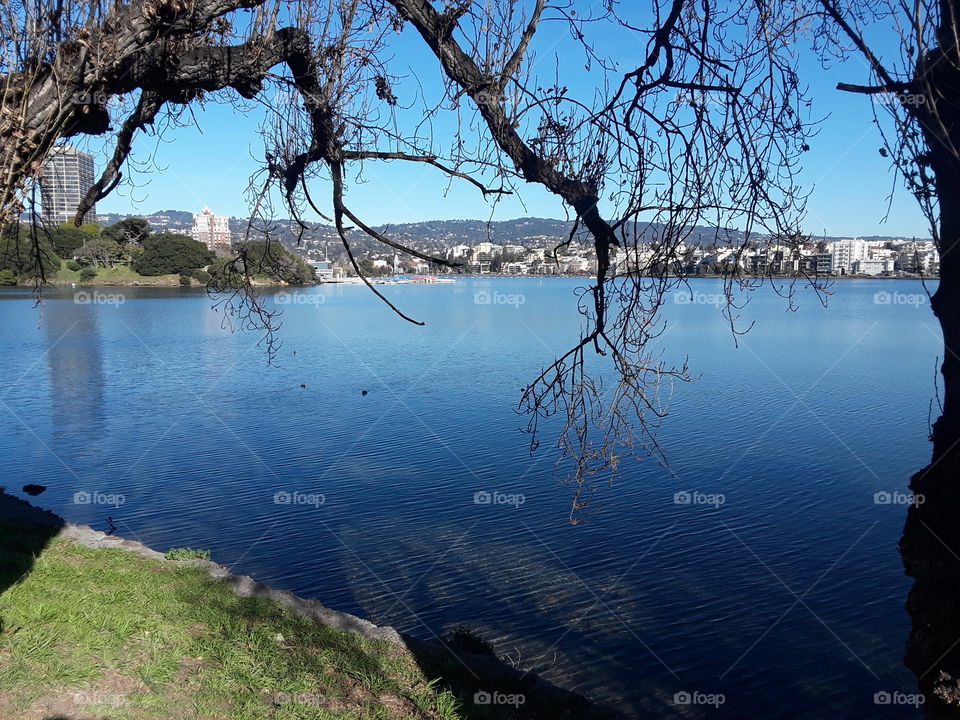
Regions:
[[0, 278, 940, 718]]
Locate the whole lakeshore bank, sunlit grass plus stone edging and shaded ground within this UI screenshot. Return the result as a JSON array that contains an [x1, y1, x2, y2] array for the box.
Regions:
[[0, 516, 622, 720]]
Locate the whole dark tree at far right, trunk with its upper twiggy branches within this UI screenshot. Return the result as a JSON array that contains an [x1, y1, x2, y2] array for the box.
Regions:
[[810, 0, 960, 717]]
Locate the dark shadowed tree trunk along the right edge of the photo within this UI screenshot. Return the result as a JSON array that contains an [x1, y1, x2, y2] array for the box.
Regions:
[[900, 38, 960, 718]]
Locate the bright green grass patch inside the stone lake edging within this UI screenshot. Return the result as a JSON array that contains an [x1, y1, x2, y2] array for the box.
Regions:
[[0, 522, 460, 720]]
